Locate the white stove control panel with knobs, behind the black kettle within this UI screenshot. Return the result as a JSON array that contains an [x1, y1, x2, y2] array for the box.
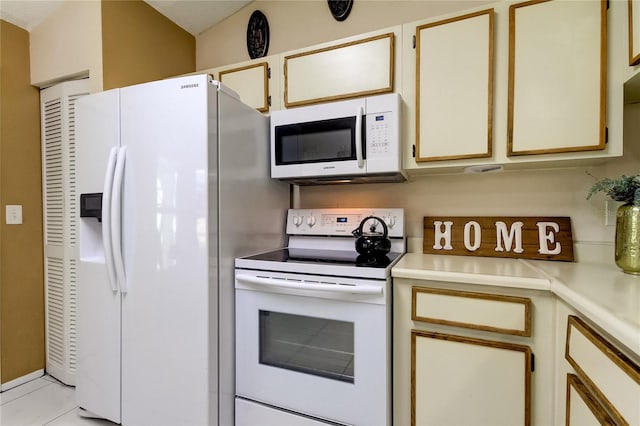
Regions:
[[287, 208, 405, 237]]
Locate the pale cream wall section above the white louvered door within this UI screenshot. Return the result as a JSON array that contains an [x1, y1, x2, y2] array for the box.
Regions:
[[30, 0, 102, 92]]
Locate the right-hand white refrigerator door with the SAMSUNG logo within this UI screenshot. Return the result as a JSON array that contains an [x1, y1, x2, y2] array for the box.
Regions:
[[121, 76, 211, 426]]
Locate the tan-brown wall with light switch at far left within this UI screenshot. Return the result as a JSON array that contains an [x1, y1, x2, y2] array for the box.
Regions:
[[0, 21, 45, 383]]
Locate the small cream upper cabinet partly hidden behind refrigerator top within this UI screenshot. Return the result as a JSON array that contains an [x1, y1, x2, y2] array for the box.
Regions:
[[203, 56, 281, 112]]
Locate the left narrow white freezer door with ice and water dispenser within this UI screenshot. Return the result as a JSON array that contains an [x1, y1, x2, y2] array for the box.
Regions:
[[76, 89, 121, 423]]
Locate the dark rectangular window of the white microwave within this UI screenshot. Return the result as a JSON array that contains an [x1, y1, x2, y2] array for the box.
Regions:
[[275, 117, 365, 165]]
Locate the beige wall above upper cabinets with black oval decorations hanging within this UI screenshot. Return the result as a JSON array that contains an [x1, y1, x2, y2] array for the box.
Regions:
[[196, 0, 490, 70]]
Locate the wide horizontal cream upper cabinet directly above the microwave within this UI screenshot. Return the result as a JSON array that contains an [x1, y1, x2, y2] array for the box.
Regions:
[[282, 27, 401, 108]]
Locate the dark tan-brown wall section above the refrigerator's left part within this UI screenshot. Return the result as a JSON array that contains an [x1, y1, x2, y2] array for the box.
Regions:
[[102, 0, 196, 90]]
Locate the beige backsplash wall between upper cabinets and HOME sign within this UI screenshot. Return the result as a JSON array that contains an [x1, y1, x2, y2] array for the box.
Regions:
[[300, 152, 638, 246]]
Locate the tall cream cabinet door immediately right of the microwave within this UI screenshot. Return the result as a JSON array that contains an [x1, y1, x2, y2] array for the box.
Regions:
[[415, 9, 494, 162]]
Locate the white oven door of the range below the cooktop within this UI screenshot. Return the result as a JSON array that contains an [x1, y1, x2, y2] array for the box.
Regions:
[[236, 270, 391, 425]]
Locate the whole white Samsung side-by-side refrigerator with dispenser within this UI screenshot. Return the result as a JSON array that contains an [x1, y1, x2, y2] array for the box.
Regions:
[[75, 75, 289, 426]]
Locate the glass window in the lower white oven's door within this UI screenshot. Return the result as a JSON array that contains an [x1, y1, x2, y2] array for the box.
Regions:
[[260, 310, 354, 383]]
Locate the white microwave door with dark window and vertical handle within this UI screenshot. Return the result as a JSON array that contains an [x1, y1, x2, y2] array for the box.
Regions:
[[271, 99, 367, 179]]
